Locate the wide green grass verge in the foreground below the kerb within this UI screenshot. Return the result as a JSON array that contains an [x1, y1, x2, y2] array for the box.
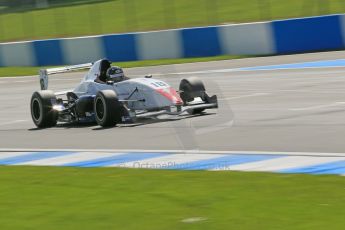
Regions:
[[0, 167, 345, 230]]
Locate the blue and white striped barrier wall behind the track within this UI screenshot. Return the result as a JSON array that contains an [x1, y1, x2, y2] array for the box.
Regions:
[[0, 15, 345, 66]]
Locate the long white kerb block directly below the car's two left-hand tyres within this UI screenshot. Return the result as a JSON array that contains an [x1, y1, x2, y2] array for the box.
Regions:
[[16, 152, 123, 166]]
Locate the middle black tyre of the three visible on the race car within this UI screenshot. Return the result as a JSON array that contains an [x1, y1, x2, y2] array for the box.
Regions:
[[94, 90, 122, 127]]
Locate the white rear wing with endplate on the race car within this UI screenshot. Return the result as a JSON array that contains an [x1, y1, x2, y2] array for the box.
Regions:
[[39, 63, 93, 90]]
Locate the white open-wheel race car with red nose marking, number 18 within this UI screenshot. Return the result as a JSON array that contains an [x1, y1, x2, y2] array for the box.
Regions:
[[30, 59, 218, 128]]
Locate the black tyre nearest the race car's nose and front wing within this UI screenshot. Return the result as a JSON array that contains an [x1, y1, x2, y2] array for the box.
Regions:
[[179, 77, 206, 114]]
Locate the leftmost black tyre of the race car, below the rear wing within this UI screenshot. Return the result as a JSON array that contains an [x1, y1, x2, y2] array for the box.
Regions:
[[30, 90, 58, 128]]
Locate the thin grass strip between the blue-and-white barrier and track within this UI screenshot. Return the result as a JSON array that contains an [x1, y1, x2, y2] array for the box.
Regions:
[[0, 55, 242, 77]]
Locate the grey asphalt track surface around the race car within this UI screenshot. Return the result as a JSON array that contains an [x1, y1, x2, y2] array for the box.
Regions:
[[0, 52, 345, 153]]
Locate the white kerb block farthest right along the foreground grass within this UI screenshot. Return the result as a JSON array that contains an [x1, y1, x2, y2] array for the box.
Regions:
[[214, 156, 345, 172]]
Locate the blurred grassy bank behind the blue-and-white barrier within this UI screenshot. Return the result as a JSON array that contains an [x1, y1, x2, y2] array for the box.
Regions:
[[0, 0, 345, 42]]
